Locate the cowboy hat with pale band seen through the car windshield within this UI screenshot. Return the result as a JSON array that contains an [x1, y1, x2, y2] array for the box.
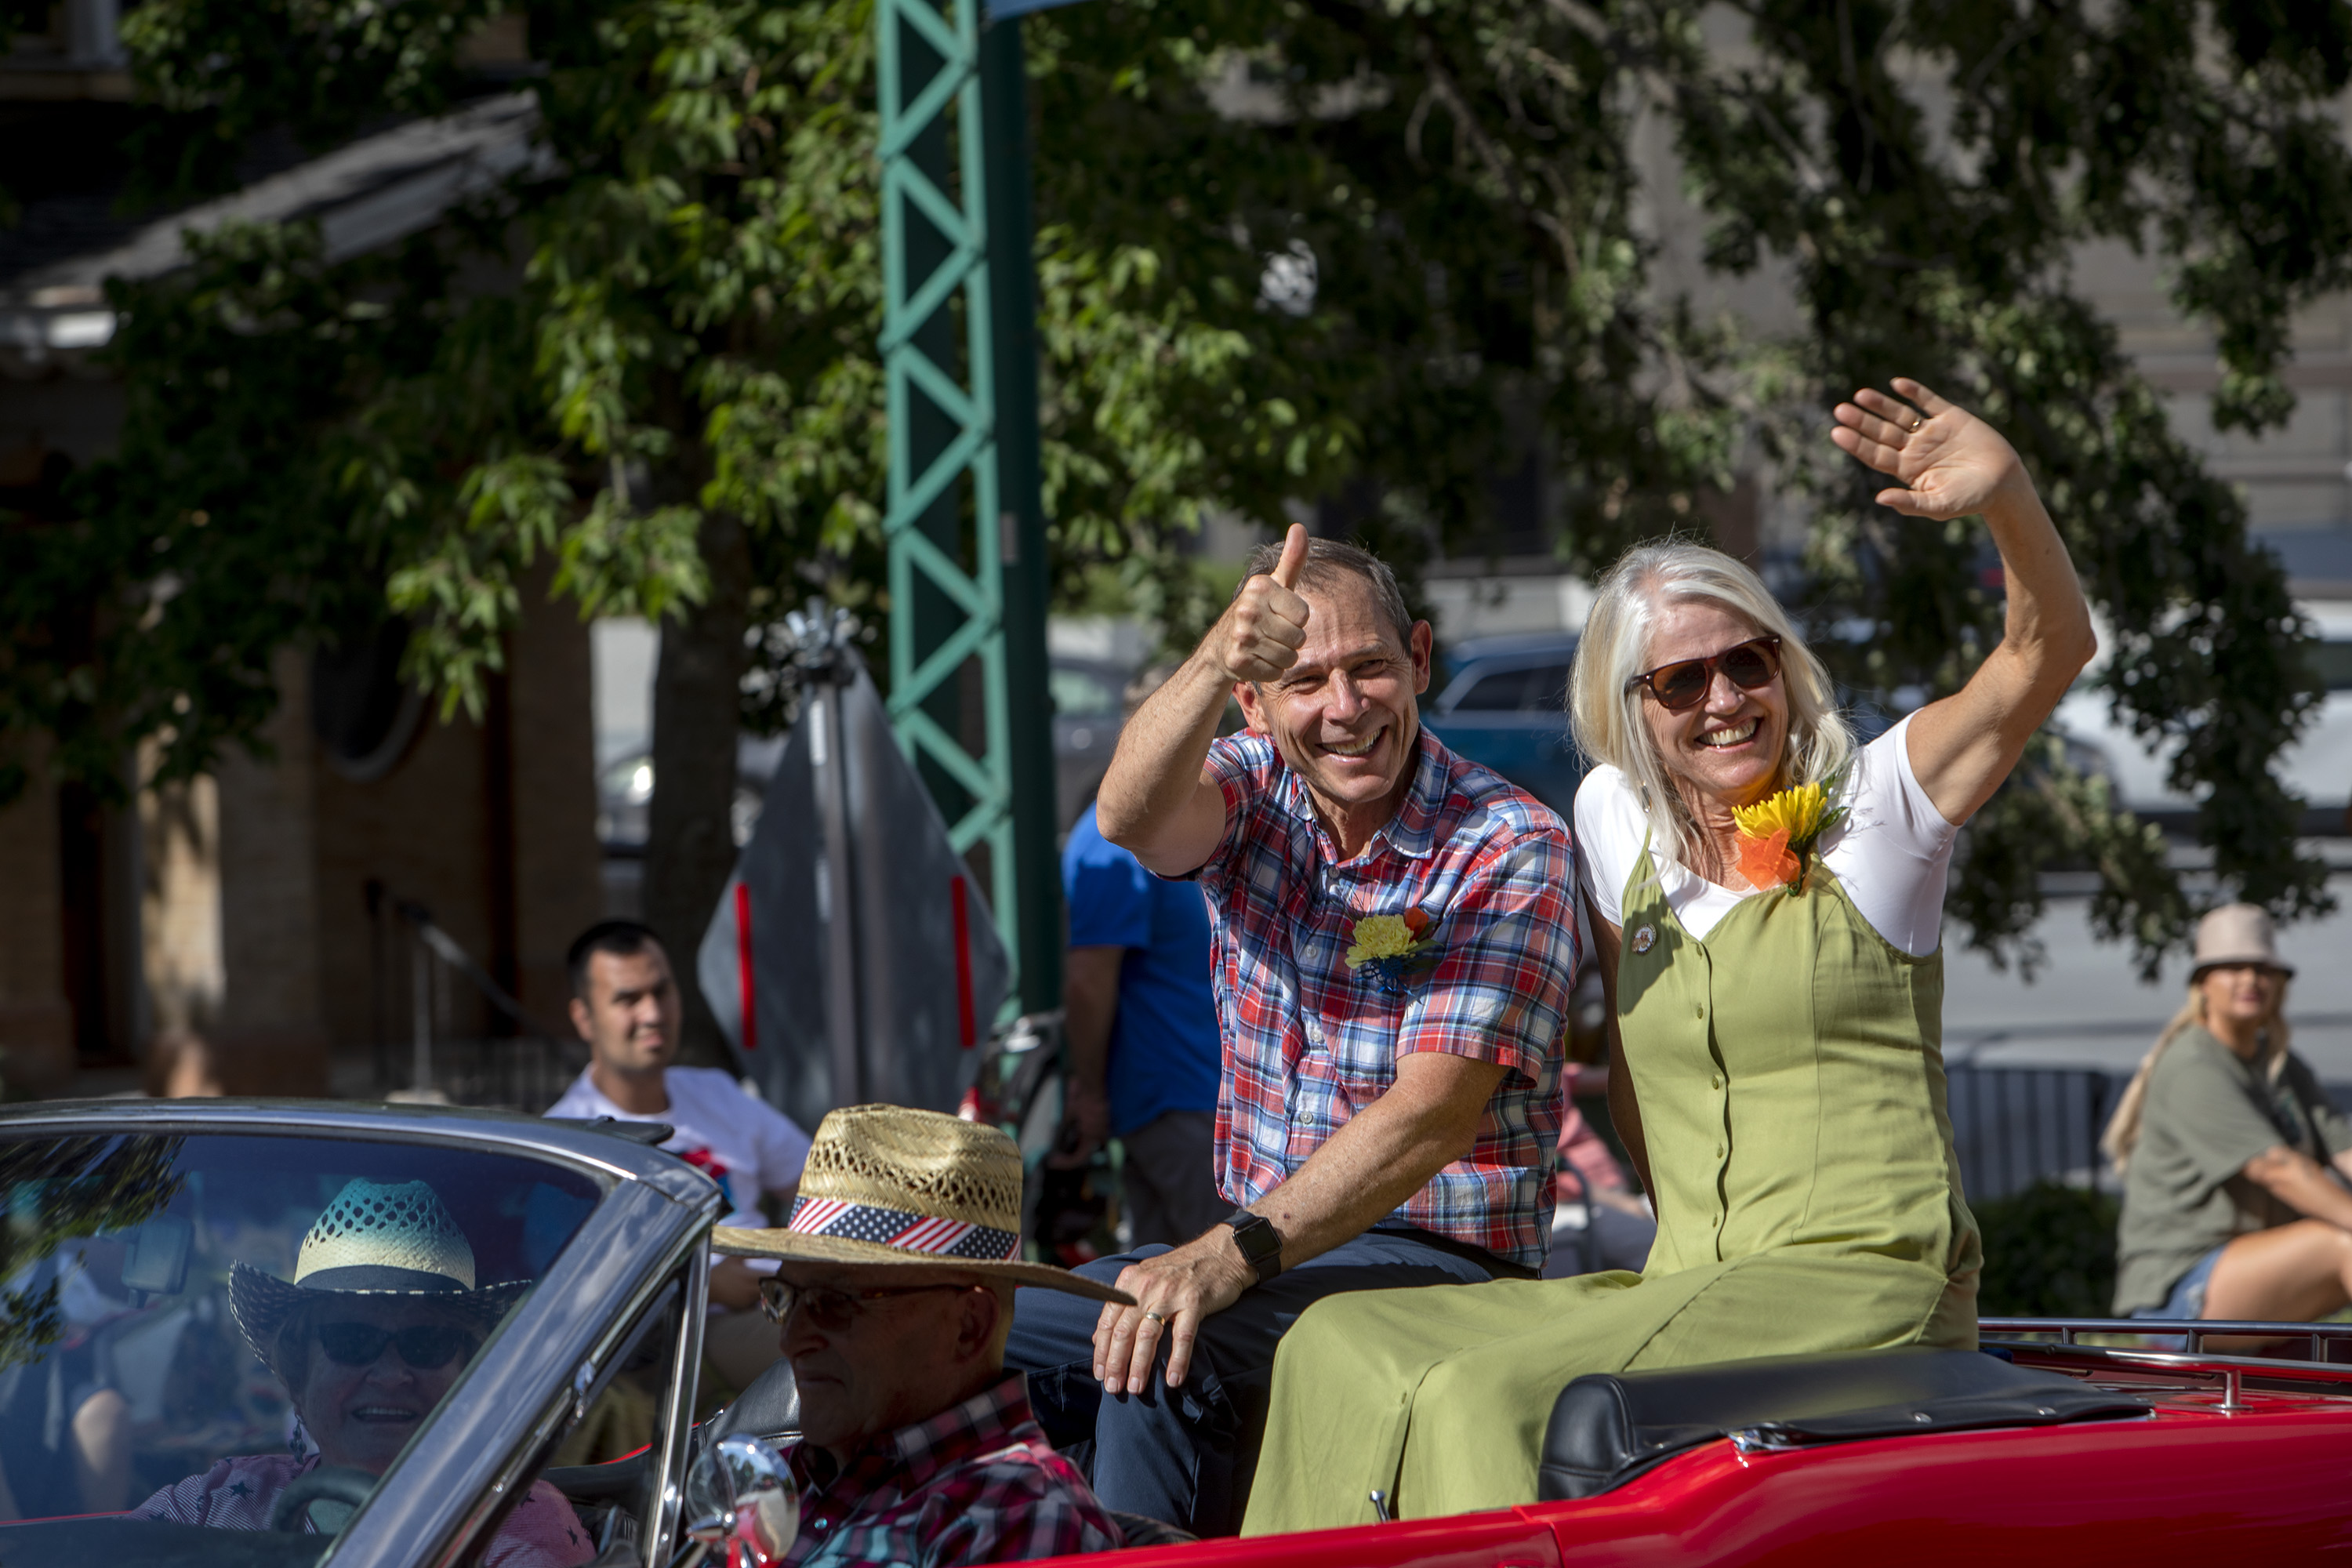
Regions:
[[228, 1175, 532, 1361]]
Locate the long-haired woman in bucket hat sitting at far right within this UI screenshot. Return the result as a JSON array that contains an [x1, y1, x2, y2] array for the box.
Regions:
[[2103, 902, 2352, 1323]]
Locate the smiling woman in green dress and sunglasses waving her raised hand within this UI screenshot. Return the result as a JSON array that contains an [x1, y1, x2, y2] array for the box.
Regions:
[[1244, 379, 2096, 1535]]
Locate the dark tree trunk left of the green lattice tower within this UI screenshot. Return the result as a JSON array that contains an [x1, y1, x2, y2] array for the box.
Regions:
[[644, 513, 750, 1067]]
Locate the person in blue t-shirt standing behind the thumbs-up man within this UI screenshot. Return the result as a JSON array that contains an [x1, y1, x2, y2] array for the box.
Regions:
[[1061, 668, 1232, 1246]]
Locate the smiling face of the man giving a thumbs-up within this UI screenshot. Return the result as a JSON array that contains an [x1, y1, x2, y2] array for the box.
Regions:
[[1235, 569, 1430, 855]]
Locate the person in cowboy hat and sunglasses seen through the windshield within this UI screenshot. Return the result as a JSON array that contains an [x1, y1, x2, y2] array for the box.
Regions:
[[132, 1178, 595, 1568]]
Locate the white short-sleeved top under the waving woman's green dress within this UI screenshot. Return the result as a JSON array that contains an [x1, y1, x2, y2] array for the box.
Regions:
[[1576, 715, 1959, 959]]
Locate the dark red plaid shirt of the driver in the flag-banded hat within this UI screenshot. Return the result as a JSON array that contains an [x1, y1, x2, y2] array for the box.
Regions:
[[783, 1373, 1124, 1568]]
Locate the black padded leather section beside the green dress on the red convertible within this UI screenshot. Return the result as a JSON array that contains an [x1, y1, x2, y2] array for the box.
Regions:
[[1536, 1347, 2147, 1502]]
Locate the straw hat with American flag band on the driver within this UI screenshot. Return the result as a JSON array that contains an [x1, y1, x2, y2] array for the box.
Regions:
[[710, 1105, 1136, 1307]]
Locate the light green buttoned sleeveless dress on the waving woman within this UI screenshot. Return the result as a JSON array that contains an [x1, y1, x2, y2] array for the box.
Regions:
[[1244, 846, 1980, 1535]]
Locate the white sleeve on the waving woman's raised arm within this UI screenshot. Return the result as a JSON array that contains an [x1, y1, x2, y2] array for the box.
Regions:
[[1820, 715, 1959, 959]]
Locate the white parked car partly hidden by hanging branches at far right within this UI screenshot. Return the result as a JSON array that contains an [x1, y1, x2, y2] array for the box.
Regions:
[[2053, 600, 2352, 834]]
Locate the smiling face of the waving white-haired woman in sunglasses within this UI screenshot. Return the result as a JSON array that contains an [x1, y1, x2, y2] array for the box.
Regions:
[[1642, 600, 1788, 811]]
